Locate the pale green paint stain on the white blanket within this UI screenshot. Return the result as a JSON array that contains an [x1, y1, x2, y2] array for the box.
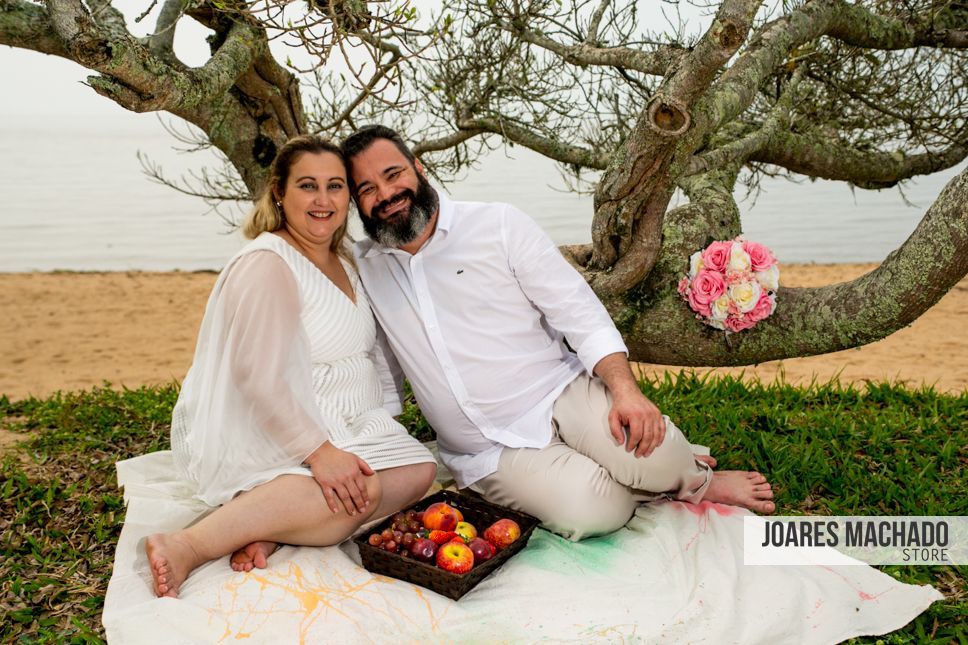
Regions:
[[518, 529, 627, 573]]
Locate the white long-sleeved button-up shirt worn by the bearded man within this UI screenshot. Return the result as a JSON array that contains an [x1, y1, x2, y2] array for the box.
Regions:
[[355, 191, 627, 488]]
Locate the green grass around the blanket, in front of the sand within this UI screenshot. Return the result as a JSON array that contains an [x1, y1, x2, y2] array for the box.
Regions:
[[0, 373, 968, 643]]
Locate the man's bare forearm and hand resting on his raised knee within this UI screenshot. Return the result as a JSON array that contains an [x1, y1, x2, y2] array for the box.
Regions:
[[595, 353, 665, 457]]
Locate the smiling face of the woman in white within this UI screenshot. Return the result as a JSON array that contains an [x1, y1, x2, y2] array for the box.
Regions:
[[276, 152, 350, 247]]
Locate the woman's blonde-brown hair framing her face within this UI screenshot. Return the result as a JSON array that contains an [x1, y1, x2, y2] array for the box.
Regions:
[[242, 134, 353, 261]]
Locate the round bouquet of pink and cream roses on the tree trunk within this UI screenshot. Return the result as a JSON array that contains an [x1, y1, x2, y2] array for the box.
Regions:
[[679, 237, 780, 333]]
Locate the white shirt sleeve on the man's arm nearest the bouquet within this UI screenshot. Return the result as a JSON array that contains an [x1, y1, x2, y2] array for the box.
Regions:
[[503, 205, 628, 374]]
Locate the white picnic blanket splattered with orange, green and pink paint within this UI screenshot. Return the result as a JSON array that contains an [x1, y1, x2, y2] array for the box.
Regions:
[[102, 452, 942, 644]]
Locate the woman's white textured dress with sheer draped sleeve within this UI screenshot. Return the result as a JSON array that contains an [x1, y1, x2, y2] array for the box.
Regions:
[[171, 233, 434, 506]]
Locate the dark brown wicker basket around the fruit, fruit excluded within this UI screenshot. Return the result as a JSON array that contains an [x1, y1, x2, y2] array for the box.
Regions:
[[353, 490, 538, 600]]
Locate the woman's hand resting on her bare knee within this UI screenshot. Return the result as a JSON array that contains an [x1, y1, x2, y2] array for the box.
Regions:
[[306, 441, 374, 515]]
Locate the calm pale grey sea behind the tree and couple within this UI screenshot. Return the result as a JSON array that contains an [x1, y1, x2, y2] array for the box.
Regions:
[[0, 110, 964, 272]]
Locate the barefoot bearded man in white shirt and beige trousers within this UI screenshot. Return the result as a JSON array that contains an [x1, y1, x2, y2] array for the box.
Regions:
[[342, 126, 774, 540]]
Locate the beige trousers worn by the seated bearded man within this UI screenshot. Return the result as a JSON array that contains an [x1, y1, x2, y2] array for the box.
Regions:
[[473, 374, 712, 540]]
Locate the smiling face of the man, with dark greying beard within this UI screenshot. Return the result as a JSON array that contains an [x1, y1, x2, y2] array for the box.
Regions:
[[349, 139, 438, 247]]
